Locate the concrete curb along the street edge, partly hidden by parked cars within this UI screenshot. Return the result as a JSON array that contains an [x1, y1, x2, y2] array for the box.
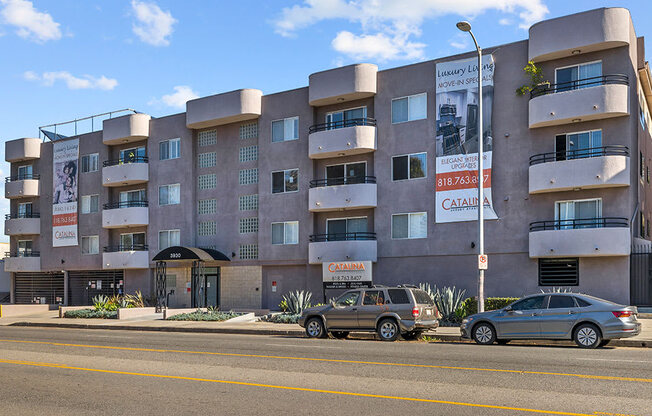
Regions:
[[8, 322, 652, 348]]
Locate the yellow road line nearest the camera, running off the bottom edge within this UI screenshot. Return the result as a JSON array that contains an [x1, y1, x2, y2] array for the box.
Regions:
[[0, 360, 608, 416]]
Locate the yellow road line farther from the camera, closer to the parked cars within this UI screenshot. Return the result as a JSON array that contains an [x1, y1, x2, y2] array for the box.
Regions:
[[0, 339, 652, 383]]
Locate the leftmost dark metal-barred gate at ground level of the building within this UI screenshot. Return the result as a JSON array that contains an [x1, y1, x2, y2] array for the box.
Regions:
[[14, 273, 64, 305]]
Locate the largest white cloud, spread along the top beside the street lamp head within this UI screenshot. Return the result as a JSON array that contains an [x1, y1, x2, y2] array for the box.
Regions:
[[274, 0, 548, 61]]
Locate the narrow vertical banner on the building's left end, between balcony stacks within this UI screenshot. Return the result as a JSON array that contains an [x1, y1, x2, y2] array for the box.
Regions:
[[52, 139, 79, 247]]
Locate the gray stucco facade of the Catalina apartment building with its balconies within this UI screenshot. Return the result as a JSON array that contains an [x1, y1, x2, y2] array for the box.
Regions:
[[5, 8, 652, 309]]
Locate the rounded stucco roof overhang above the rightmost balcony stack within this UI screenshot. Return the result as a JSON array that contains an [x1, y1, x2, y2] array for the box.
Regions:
[[528, 8, 633, 62]]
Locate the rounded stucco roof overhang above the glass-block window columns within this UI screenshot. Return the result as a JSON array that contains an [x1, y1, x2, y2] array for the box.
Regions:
[[186, 89, 263, 129]]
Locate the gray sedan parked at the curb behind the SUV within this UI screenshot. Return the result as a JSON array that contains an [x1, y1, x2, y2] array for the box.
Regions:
[[460, 293, 641, 348]]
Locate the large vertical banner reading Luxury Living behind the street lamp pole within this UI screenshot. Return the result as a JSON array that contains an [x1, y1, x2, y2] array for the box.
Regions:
[[435, 55, 497, 223]]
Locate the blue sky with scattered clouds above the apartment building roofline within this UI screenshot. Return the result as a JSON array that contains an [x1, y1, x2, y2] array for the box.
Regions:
[[0, 0, 652, 224]]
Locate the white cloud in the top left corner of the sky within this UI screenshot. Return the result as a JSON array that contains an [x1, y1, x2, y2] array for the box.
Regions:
[[0, 0, 61, 43]]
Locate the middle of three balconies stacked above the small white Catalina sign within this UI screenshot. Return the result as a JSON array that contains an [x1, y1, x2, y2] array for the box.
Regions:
[[308, 176, 377, 212]]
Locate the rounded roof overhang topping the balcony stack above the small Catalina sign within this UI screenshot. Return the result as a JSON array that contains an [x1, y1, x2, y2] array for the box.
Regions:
[[308, 64, 378, 107]]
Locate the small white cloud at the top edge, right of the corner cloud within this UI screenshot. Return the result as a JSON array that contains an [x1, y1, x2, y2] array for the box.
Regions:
[[131, 0, 177, 46]]
